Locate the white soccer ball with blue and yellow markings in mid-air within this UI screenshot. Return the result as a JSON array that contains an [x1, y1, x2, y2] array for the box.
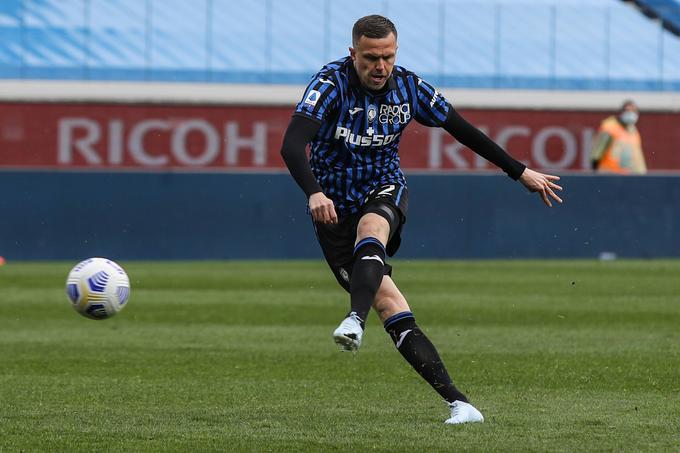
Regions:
[[66, 258, 130, 319]]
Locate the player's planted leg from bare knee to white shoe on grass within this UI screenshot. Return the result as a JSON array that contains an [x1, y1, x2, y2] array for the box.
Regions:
[[374, 275, 484, 425]]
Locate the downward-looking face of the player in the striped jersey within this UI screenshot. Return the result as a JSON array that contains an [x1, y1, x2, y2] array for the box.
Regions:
[[349, 33, 397, 90]]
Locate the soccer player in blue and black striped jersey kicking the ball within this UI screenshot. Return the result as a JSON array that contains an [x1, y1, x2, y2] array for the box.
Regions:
[[281, 15, 562, 424]]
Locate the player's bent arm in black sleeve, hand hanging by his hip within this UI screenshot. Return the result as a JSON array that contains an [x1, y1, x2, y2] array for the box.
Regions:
[[281, 115, 338, 223]]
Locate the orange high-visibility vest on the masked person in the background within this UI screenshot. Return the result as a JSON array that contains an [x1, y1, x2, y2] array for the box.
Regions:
[[597, 116, 647, 174]]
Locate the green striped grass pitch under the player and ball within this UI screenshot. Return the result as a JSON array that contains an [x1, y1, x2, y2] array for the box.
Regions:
[[0, 260, 680, 452]]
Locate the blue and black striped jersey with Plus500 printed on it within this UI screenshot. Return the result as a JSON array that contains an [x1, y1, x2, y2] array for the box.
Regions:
[[294, 57, 450, 215]]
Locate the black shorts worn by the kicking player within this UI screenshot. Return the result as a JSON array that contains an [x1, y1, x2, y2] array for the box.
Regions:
[[314, 184, 408, 292]]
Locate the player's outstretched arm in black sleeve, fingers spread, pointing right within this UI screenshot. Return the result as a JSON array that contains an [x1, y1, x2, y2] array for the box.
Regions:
[[442, 105, 562, 207]]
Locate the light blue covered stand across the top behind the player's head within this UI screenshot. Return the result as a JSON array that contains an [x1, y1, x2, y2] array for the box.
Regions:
[[0, 0, 680, 91]]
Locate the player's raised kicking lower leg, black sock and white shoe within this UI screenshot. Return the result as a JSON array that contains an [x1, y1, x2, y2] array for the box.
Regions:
[[333, 237, 385, 351]]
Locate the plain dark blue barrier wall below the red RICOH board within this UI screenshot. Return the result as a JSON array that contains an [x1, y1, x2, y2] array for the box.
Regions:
[[0, 172, 680, 260]]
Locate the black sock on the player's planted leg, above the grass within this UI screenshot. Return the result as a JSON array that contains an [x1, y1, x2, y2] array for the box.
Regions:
[[385, 311, 468, 403]]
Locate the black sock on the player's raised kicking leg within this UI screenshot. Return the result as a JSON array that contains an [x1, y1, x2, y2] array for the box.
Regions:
[[349, 237, 385, 327]]
